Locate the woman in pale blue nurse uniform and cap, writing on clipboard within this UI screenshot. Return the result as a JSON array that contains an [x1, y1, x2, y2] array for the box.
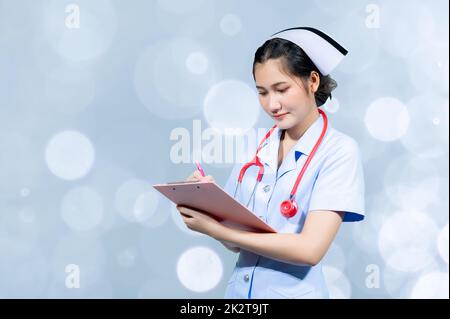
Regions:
[[178, 28, 364, 299]]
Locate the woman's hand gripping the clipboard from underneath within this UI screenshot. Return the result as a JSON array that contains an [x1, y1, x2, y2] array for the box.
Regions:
[[177, 205, 225, 239]]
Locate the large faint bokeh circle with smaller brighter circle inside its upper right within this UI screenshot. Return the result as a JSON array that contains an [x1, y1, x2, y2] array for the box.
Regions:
[[134, 38, 218, 120]]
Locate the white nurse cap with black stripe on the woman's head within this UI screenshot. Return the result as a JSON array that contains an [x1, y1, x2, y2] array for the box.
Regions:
[[271, 27, 348, 75]]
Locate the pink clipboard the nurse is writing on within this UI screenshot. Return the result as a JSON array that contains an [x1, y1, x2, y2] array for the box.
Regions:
[[152, 181, 276, 233]]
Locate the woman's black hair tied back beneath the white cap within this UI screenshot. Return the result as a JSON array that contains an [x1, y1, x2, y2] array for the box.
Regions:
[[253, 38, 337, 107]]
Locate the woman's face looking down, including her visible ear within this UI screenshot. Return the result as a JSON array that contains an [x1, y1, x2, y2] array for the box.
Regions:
[[255, 59, 319, 129]]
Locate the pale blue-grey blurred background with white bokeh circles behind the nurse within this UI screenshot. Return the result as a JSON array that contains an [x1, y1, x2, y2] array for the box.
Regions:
[[0, 0, 449, 298]]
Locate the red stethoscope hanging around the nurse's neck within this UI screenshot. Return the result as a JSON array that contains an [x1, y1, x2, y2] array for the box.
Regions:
[[234, 109, 328, 218]]
